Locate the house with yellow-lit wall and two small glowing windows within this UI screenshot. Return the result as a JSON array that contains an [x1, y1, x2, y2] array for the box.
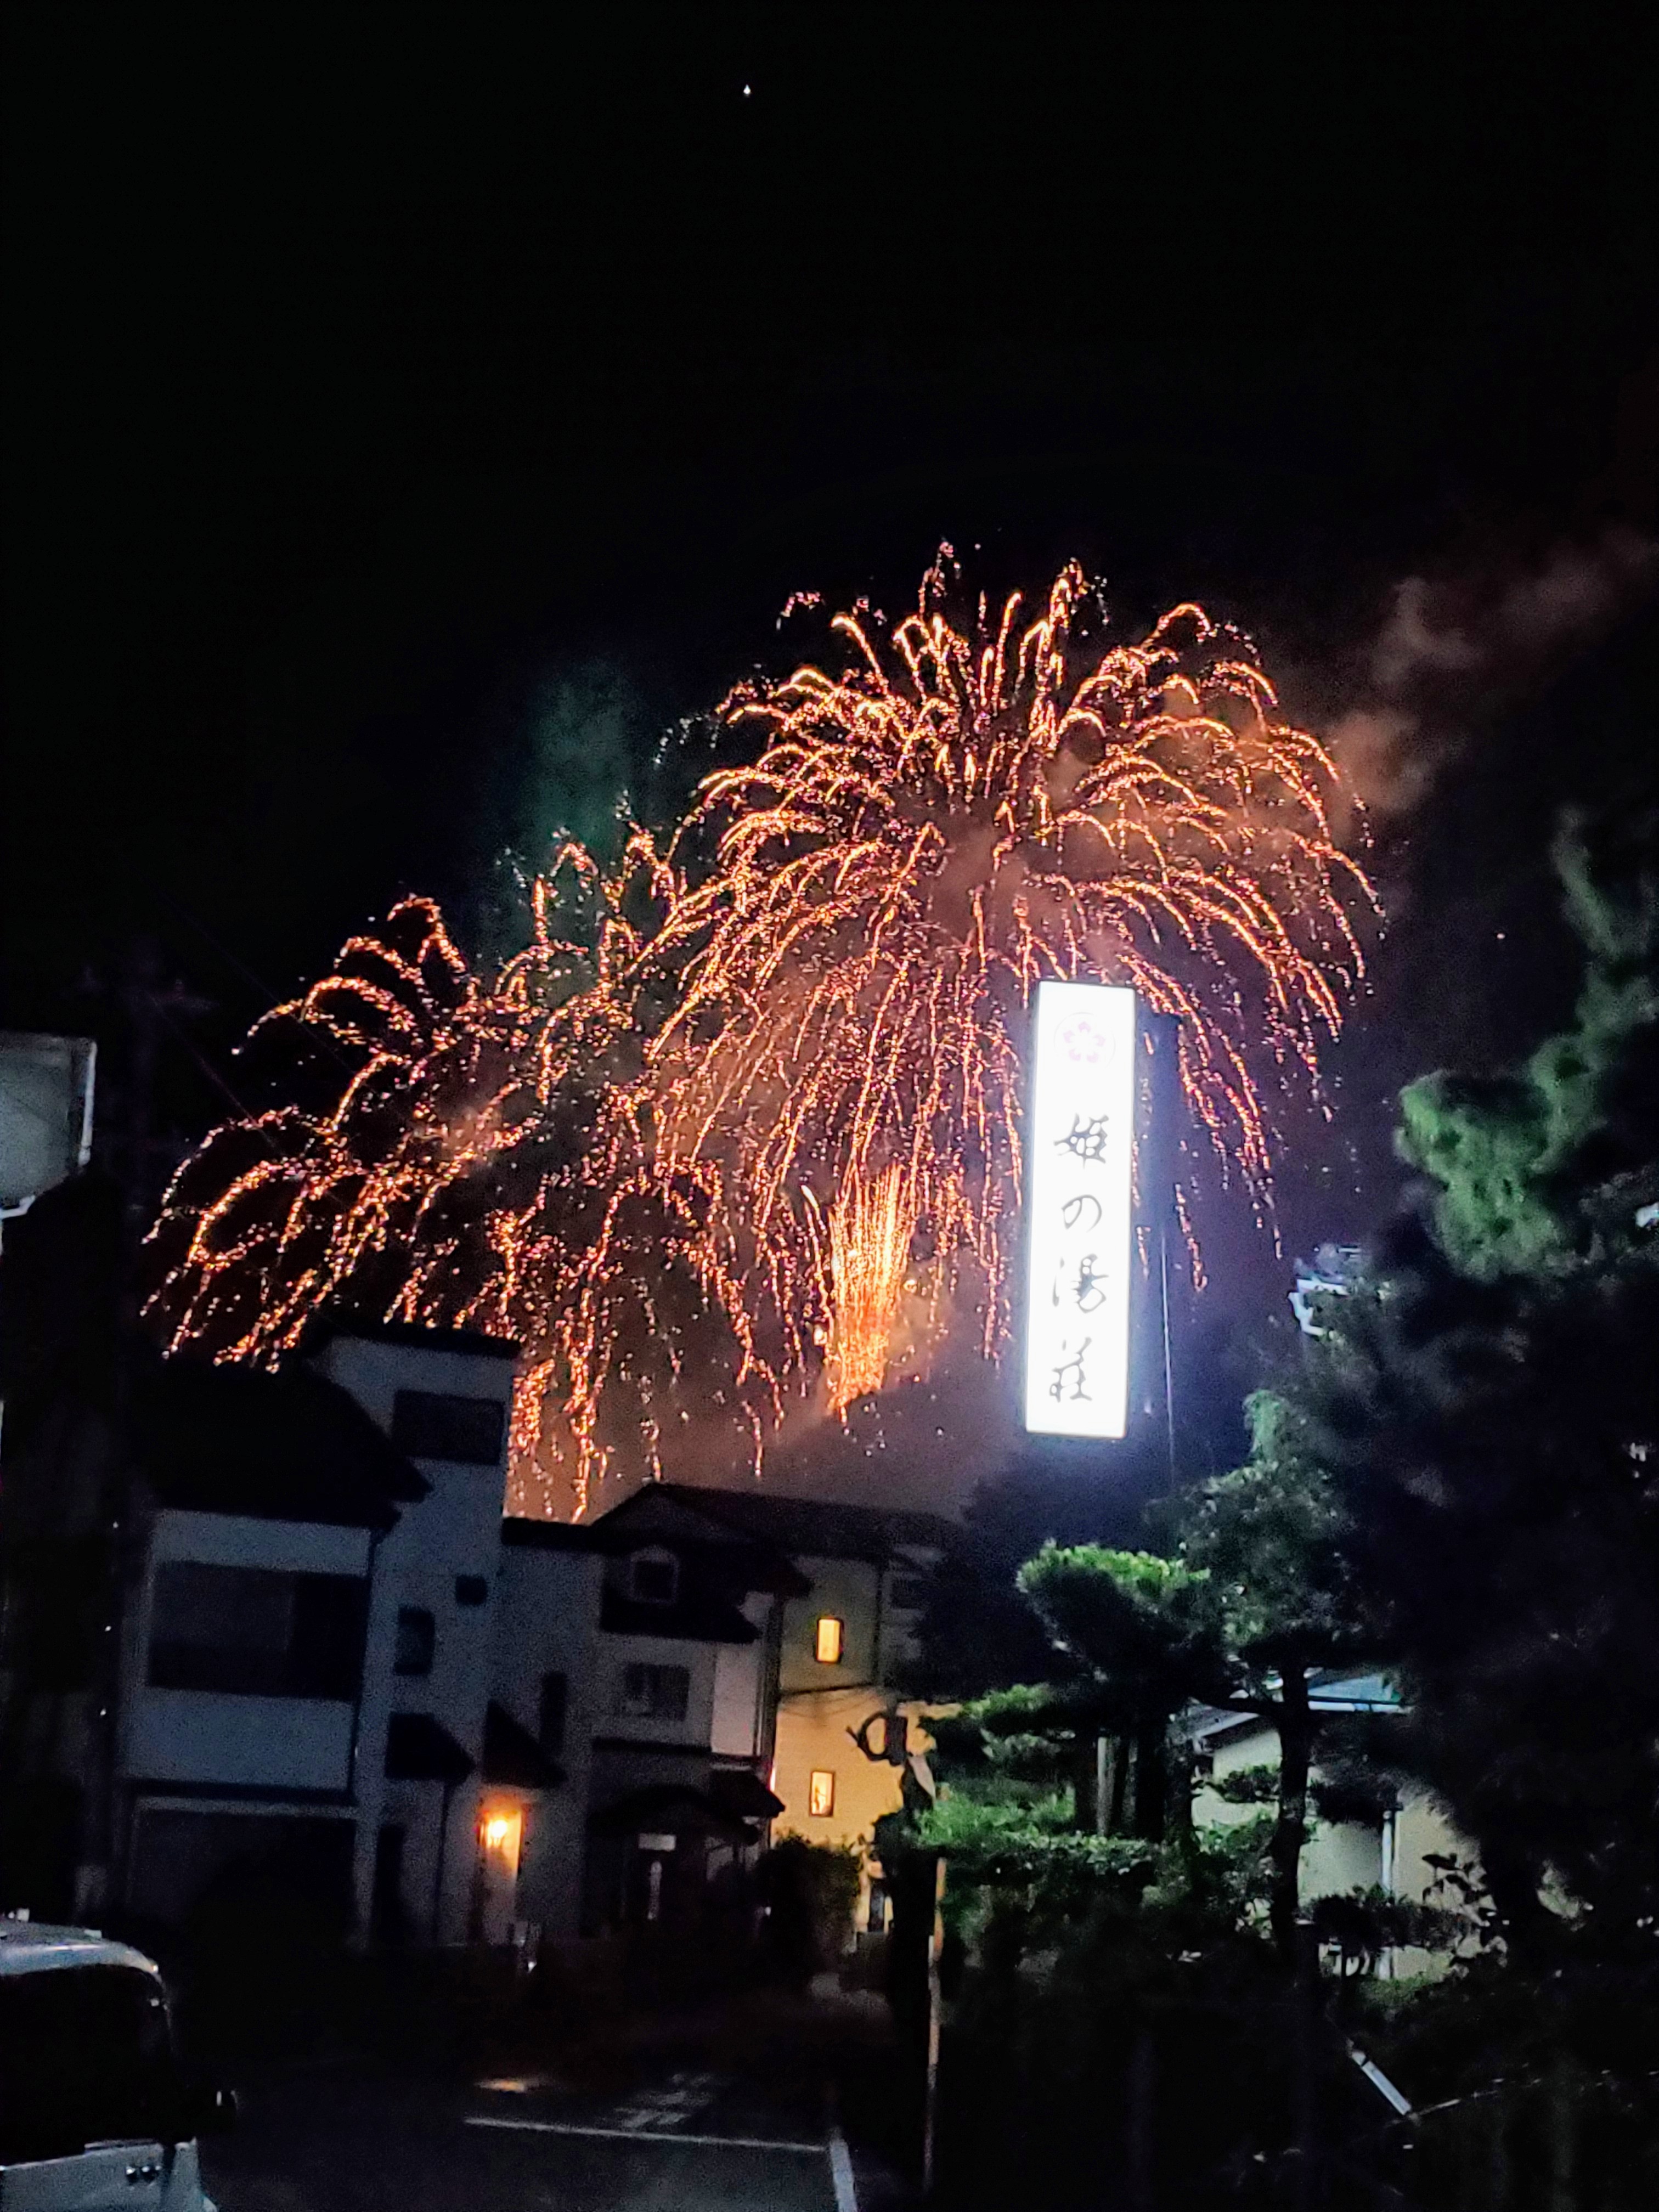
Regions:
[[506, 1482, 945, 1929]]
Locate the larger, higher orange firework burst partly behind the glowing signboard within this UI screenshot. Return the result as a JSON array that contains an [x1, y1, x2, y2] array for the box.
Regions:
[[652, 562, 1369, 1402]]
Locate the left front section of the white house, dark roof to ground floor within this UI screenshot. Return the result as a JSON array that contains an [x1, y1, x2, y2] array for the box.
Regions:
[[115, 1361, 427, 1922]]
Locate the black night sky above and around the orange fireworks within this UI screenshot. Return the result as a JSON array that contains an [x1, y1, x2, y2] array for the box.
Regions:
[[0, 7, 1659, 1486]]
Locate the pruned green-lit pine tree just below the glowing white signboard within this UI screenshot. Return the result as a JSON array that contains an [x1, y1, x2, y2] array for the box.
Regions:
[[916, 1391, 1361, 1957]]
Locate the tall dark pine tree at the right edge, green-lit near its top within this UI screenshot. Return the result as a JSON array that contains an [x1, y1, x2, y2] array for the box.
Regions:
[[1301, 823, 1659, 1946]]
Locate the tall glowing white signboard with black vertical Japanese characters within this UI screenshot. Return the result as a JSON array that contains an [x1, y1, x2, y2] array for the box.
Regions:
[[1026, 982, 1135, 1436]]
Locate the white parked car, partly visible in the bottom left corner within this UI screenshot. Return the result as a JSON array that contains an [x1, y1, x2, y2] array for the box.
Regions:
[[0, 1920, 234, 2212]]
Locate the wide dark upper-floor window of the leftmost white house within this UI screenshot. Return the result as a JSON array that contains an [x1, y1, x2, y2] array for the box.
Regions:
[[148, 1560, 367, 1703]]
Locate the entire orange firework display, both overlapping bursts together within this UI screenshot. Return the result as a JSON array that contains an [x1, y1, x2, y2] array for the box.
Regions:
[[150, 560, 1369, 1511]]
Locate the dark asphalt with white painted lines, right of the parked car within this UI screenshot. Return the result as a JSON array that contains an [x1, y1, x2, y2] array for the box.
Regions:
[[201, 2062, 858, 2212]]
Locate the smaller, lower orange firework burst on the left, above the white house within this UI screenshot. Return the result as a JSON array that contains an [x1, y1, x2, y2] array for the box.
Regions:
[[150, 836, 778, 1511]]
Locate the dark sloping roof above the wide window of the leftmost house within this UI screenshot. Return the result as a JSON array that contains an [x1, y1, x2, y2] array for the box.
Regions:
[[133, 1358, 429, 1528]]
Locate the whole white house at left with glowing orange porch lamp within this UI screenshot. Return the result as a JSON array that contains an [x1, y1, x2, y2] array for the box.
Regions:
[[4, 1300, 564, 1942]]
